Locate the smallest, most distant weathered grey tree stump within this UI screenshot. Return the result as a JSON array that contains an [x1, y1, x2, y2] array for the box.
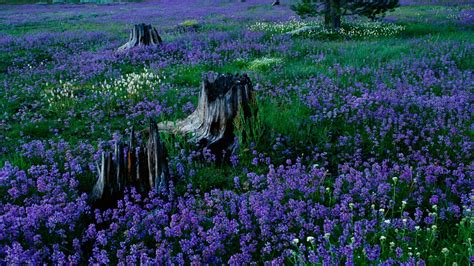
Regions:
[[118, 23, 163, 51]]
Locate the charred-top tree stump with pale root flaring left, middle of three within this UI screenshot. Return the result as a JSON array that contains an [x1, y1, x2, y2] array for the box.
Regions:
[[158, 73, 256, 160]]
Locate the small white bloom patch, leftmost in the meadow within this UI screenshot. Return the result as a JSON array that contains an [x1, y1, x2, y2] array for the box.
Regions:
[[44, 80, 79, 107]]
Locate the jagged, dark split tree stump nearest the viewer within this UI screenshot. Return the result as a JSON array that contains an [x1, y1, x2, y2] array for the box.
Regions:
[[90, 119, 170, 207]]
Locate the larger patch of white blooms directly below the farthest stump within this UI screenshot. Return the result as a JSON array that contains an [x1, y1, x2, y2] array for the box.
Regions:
[[92, 69, 164, 99]]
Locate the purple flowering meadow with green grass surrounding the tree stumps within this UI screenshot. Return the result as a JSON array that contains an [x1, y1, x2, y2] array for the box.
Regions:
[[0, 0, 474, 265]]
